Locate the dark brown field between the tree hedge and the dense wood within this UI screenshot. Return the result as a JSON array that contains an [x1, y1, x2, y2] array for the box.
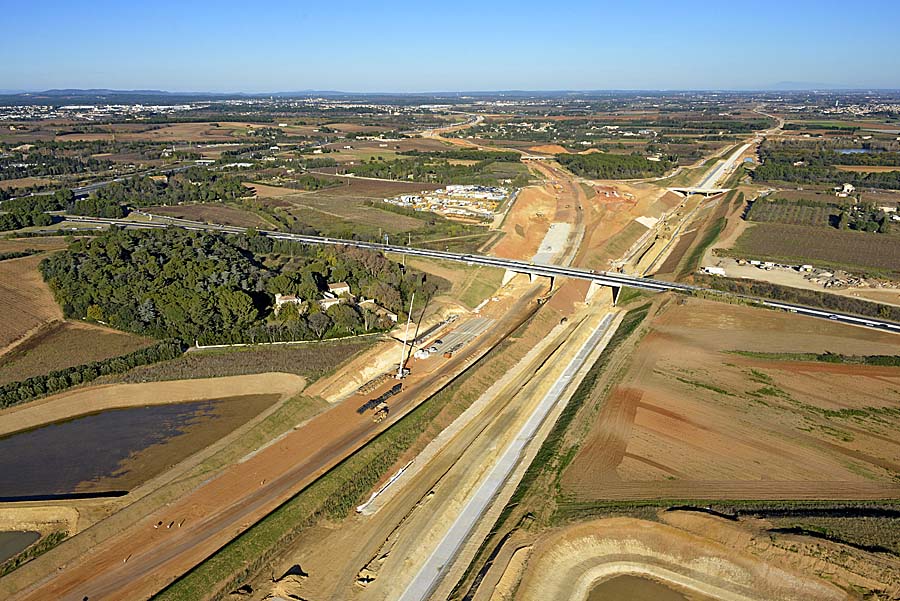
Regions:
[[0, 321, 153, 386]]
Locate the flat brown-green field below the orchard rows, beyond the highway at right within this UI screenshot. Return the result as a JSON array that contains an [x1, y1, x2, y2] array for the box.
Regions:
[[730, 223, 900, 273]]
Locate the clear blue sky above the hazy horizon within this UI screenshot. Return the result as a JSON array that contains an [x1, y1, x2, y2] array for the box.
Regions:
[[0, 0, 900, 92]]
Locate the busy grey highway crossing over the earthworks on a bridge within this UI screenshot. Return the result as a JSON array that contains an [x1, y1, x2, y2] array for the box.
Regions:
[[65, 215, 900, 334]]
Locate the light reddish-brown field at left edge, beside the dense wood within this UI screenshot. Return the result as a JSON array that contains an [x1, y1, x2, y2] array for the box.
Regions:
[[0, 255, 63, 356]]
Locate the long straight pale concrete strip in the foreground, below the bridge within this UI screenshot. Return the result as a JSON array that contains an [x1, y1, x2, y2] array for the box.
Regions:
[[400, 313, 614, 601]]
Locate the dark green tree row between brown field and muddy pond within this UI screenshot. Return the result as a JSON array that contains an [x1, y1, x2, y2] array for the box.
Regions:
[[0, 340, 186, 408]]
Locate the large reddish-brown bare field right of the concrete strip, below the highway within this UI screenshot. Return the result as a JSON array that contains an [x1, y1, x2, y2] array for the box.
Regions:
[[561, 299, 900, 504]]
